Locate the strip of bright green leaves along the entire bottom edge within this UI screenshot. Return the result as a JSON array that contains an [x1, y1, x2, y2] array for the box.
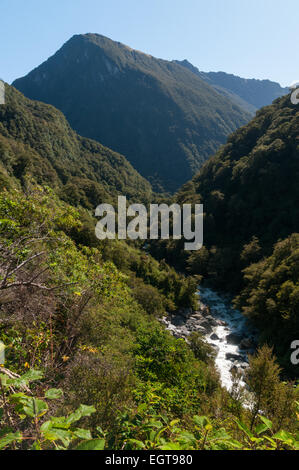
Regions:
[[0, 370, 299, 450]]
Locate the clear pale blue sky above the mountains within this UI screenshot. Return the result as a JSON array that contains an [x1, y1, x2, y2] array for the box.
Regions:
[[0, 0, 299, 86]]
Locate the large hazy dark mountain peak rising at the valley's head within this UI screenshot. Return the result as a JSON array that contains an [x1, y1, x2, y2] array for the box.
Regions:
[[14, 34, 249, 190]]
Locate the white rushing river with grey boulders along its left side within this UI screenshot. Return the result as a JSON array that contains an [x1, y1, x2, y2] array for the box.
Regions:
[[162, 287, 256, 390]]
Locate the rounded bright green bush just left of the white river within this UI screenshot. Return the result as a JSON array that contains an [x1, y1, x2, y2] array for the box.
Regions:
[[135, 325, 218, 416]]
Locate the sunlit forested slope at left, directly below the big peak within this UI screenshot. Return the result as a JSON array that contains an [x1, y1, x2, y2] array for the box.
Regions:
[[0, 85, 151, 209]]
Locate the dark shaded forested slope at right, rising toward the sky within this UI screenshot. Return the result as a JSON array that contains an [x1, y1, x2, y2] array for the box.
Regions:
[[157, 92, 299, 280]]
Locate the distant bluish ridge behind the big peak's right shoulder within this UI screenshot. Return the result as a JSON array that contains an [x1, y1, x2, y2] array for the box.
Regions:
[[175, 60, 289, 114]]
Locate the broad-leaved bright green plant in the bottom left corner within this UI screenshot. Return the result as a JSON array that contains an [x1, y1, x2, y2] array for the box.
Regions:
[[0, 370, 102, 450]]
